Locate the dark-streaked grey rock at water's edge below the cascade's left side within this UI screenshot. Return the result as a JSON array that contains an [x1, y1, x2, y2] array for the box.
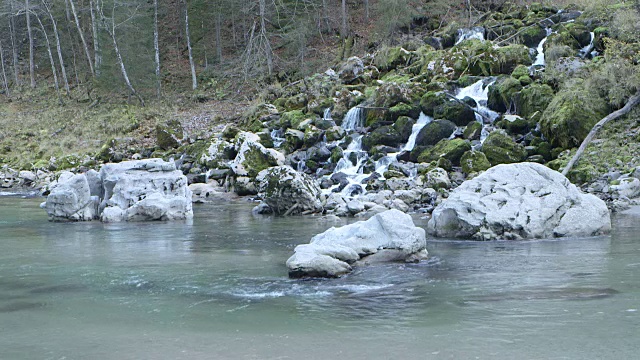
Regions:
[[256, 166, 322, 214]]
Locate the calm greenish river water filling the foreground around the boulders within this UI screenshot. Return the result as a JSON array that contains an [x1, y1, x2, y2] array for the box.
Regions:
[[0, 197, 640, 359]]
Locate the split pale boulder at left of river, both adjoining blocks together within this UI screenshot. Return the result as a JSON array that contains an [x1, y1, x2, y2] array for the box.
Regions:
[[43, 159, 193, 222]]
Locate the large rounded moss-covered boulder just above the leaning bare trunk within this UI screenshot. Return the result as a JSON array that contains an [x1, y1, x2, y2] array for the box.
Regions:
[[540, 86, 609, 149]]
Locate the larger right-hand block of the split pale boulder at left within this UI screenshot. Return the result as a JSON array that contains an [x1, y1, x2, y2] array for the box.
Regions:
[[100, 159, 193, 222]]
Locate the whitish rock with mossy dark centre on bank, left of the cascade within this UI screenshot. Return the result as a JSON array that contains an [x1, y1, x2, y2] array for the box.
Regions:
[[230, 132, 285, 178]]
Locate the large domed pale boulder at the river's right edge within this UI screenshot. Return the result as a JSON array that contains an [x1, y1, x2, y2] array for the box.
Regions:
[[427, 163, 611, 240]]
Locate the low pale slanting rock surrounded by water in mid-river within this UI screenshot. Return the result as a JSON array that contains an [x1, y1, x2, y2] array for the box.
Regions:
[[287, 210, 427, 278]]
